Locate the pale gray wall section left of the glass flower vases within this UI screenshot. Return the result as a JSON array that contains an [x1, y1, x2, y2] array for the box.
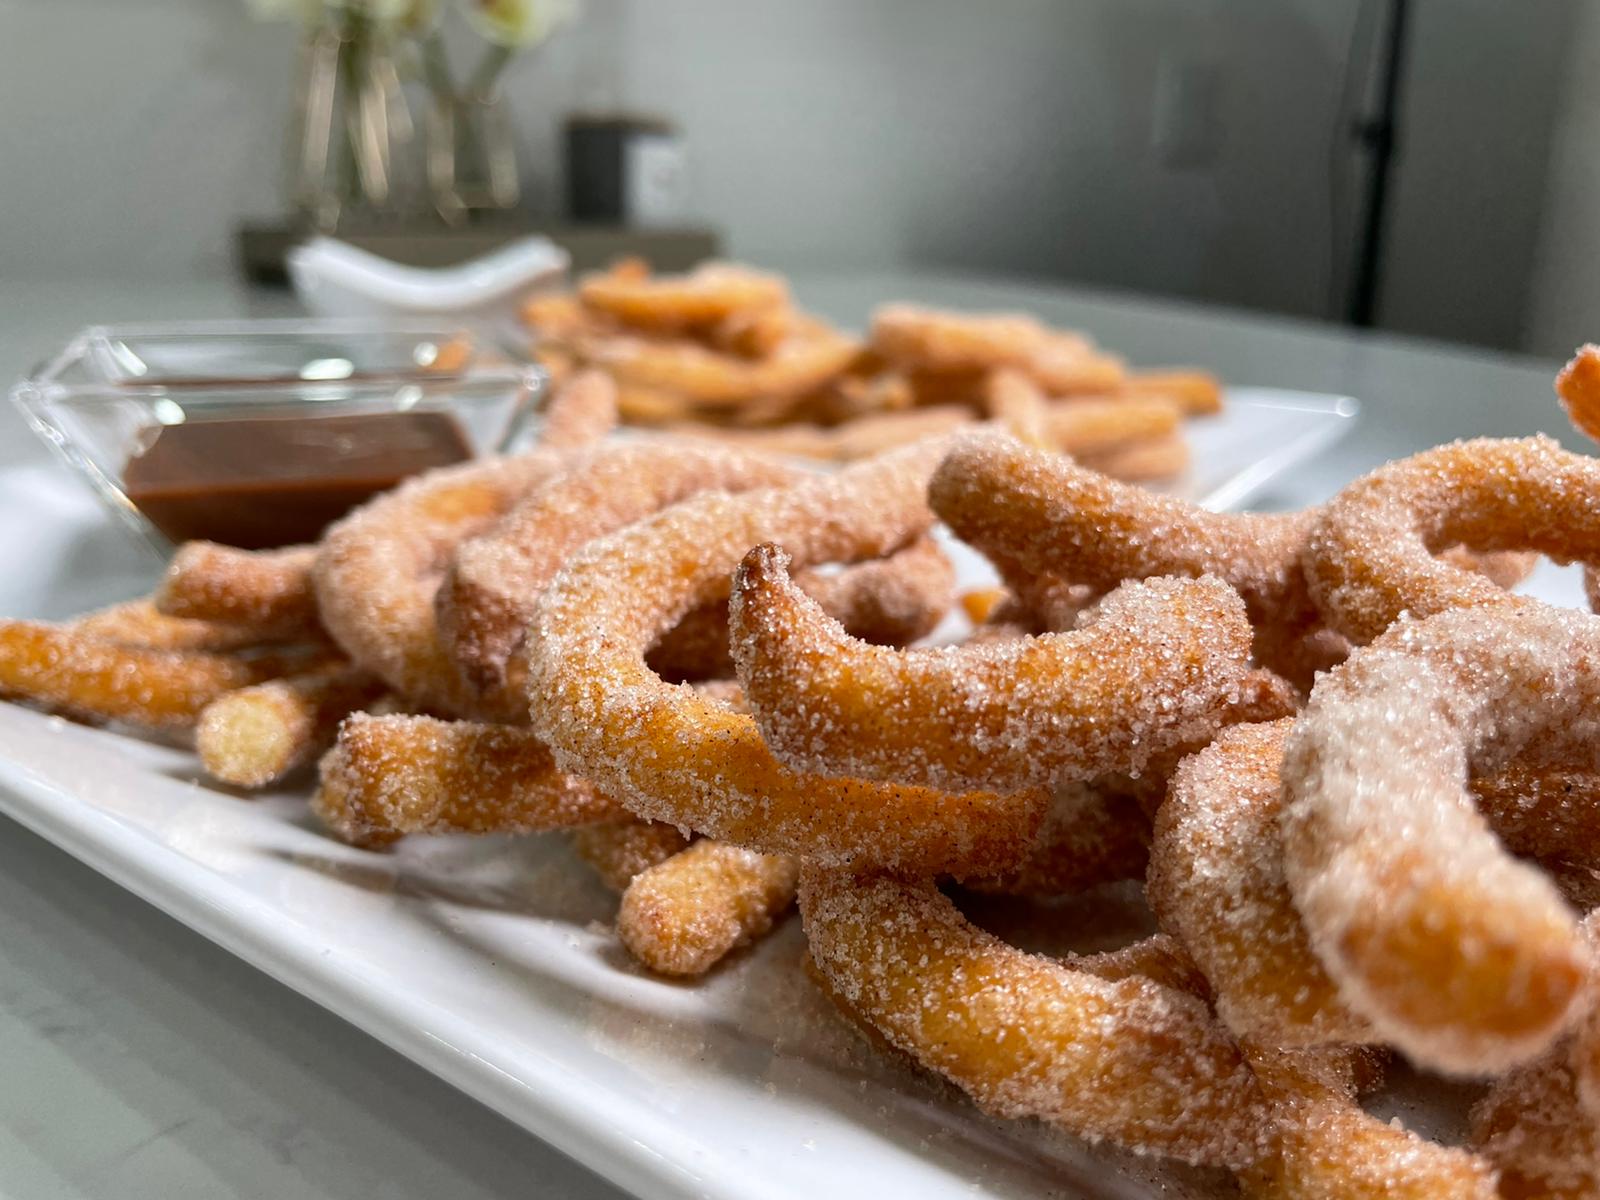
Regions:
[[0, 0, 291, 275]]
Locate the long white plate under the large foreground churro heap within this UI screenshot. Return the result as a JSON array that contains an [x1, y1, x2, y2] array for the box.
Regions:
[[0, 389, 1355, 1200]]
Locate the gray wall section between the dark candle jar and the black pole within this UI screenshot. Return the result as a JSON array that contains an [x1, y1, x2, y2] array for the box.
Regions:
[[611, 0, 1354, 324]]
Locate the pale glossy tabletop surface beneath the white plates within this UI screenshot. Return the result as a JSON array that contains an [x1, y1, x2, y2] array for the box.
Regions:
[[0, 275, 1581, 1200]]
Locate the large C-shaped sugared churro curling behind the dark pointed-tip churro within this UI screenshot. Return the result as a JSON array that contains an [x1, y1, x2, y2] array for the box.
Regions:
[[528, 445, 1048, 874]]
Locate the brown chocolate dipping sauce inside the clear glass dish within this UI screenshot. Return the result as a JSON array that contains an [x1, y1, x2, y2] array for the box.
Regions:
[[122, 413, 472, 550]]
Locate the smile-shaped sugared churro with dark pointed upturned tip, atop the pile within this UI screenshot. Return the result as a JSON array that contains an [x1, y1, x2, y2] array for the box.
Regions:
[[730, 546, 1250, 790]]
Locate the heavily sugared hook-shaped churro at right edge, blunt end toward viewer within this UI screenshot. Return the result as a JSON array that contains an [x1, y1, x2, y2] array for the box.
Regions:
[[1280, 605, 1600, 1074]]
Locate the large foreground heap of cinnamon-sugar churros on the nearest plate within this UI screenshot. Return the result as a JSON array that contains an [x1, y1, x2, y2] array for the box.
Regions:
[[9, 322, 1600, 1200]]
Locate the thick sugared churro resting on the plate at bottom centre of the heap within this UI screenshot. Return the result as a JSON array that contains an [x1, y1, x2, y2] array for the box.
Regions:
[[800, 866, 1269, 1168]]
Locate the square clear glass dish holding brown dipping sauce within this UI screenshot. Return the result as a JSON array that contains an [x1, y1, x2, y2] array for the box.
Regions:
[[11, 320, 544, 554]]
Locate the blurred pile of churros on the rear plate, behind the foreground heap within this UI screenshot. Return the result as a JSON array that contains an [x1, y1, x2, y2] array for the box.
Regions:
[[522, 259, 1222, 480]]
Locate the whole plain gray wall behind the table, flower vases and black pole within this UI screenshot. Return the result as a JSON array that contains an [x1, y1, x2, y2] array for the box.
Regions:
[[0, 0, 1576, 355]]
